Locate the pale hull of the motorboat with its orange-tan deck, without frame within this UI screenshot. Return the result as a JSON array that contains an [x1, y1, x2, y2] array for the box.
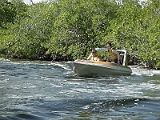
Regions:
[[65, 60, 132, 76]]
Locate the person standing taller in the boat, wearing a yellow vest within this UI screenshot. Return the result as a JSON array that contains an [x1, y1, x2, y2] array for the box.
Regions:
[[106, 43, 120, 64]]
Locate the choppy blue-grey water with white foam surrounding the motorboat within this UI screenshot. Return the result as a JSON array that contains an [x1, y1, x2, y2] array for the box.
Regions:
[[0, 60, 160, 120]]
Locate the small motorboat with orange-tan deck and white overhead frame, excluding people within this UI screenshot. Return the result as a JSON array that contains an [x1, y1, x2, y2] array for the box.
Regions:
[[66, 48, 132, 76]]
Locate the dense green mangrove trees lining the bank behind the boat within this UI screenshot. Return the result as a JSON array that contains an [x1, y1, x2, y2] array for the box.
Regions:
[[0, 0, 160, 68]]
